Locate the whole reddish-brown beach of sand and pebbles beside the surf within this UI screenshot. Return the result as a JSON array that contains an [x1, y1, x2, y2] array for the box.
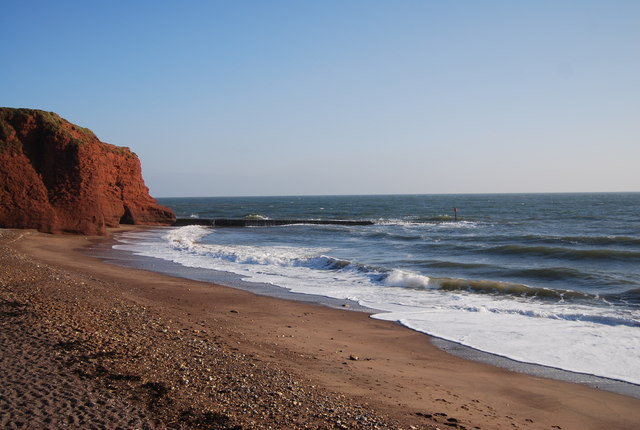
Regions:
[[0, 230, 640, 429]]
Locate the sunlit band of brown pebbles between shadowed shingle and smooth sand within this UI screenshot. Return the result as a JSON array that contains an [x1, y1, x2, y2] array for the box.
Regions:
[[0, 232, 399, 429]]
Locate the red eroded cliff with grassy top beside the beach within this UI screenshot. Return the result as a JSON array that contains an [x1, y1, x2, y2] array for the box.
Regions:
[[0, 108, 175, 235]]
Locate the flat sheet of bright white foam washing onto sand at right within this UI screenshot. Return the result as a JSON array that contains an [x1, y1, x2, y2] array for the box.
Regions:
[[364, 296, 640, 384]]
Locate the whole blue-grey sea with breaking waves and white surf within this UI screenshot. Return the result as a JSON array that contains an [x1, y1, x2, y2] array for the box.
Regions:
[[114, 193, 640, 384]]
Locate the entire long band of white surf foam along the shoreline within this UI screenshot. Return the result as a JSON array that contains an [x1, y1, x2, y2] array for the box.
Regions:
[[115, 226, 640, 384]]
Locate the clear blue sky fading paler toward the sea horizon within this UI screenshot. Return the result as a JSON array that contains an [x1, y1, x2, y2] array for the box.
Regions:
[[0, 0, 640, 197]]
